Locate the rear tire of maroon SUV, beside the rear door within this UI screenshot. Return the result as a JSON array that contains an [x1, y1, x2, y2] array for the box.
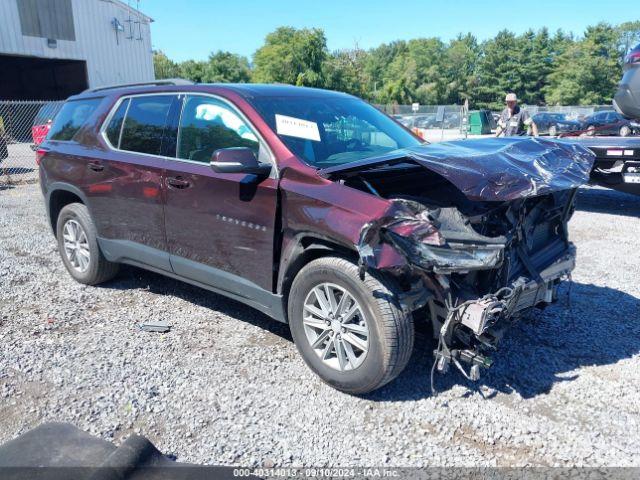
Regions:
[[56, 203, 120, 285]]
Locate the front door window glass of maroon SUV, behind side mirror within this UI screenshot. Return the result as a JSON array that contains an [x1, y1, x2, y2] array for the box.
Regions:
[[177, 96, 260, 162]]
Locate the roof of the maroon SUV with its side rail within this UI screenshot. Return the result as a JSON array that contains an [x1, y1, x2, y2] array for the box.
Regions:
[[70, 83, 351, 99]]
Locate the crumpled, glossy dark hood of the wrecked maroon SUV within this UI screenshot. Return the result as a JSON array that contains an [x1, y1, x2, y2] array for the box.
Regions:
[[319, 137, 595, 201]]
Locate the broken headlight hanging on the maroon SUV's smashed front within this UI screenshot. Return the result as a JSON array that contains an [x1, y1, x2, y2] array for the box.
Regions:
[[390, 233, 504, 273]]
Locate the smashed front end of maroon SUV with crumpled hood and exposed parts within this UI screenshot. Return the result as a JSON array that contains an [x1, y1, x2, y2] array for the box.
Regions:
[[322, 140, 593, 380]]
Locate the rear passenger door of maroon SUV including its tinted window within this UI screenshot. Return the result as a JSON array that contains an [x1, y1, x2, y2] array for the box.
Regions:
[[85, 94, 177, 271]]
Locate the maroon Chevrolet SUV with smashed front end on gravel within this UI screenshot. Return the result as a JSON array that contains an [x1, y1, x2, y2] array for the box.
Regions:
[[38, 81, 593, 393]]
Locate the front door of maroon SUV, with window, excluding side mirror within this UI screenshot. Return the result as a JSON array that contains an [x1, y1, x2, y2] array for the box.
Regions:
[[164, 95, 278, 297]]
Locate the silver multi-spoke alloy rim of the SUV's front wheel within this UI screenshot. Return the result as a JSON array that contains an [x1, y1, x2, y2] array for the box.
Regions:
[[302, 283, 369, 371]]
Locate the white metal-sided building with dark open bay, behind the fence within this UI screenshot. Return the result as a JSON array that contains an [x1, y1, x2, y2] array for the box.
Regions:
[[0, 0, 154, 100]]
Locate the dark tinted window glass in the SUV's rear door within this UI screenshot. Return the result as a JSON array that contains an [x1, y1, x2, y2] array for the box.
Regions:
[[120, 95, 175, 155]]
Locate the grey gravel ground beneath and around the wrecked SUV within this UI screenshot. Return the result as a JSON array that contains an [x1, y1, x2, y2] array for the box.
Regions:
[[0, 185, 640, 466]]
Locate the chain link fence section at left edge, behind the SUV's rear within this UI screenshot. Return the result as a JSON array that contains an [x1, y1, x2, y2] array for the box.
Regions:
[[0, 100, 64, 184]]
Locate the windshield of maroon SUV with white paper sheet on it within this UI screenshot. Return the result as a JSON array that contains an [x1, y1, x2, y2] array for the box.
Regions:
[[251, 96, 422, 168]]
